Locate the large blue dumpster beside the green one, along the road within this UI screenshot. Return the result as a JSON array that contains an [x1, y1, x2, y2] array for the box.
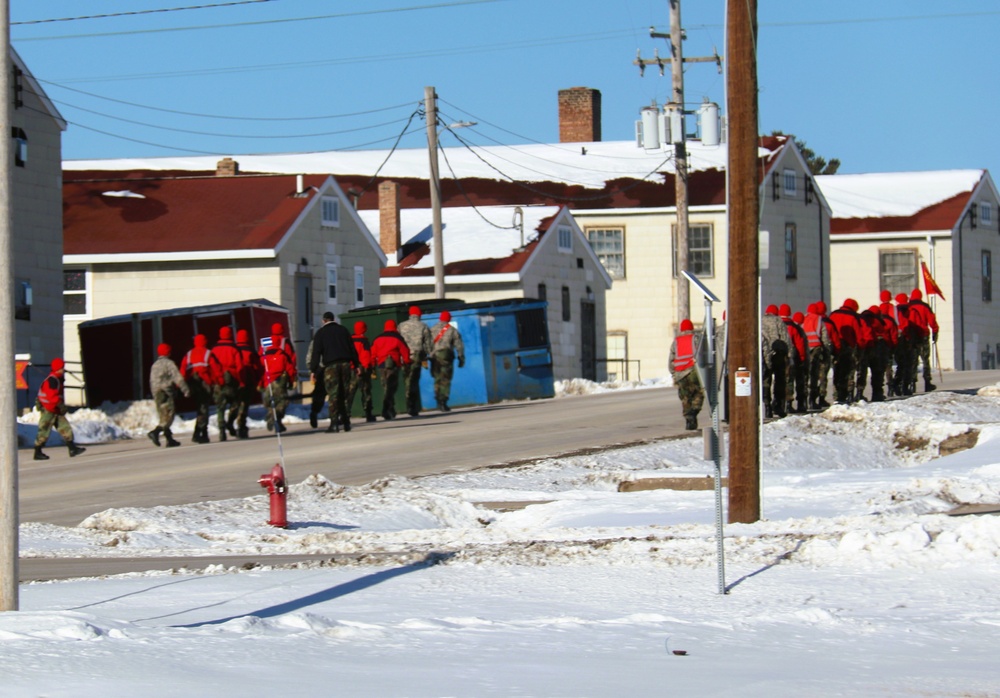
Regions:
[[420, 298, 555, 408]]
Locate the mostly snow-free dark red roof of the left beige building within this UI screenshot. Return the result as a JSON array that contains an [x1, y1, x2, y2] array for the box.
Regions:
[[63, 172, 327, 255]]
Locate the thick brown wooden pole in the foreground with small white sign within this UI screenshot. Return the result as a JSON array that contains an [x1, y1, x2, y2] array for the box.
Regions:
[[726, 0, 761, 523]]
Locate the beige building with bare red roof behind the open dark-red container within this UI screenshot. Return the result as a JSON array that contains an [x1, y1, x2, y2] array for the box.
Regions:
[[63, 165, 386, 398]]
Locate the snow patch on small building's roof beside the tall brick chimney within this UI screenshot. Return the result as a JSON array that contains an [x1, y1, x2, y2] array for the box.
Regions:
[[358, 206, 559, 269]]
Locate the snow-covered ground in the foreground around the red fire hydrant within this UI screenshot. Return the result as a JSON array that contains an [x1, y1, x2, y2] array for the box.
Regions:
[[0, 386, 1000, 698]]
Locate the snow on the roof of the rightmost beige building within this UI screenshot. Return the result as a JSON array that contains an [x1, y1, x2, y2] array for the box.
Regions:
[[816, 170, 984, 218]]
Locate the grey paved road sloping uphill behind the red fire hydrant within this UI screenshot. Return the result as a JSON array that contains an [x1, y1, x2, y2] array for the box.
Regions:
[[19, 388, 684, 525]]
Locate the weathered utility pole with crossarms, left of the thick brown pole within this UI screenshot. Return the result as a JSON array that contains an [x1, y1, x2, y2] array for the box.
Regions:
[[634, 0, 721, 322]]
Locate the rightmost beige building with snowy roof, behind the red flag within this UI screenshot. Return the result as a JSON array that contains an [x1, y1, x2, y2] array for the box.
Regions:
[[817, 170, 1000, 370]]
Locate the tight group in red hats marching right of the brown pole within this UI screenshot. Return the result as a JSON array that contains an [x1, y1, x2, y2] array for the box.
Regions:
[[761, 289, 938, 417]]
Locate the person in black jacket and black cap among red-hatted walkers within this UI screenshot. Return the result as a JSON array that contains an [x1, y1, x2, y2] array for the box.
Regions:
[[309, 311, 360, 433]]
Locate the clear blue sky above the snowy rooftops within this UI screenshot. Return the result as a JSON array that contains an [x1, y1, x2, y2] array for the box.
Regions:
[[11, 0, 1000, 177]]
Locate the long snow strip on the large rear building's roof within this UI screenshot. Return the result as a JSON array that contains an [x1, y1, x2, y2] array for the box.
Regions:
[[63, 140, 764, 188]]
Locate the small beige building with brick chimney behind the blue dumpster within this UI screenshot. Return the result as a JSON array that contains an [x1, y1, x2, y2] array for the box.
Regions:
[[362, 201, 611, 380]]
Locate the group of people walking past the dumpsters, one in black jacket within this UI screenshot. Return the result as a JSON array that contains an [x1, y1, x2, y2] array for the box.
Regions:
[[145, 306, 465, 446]]
